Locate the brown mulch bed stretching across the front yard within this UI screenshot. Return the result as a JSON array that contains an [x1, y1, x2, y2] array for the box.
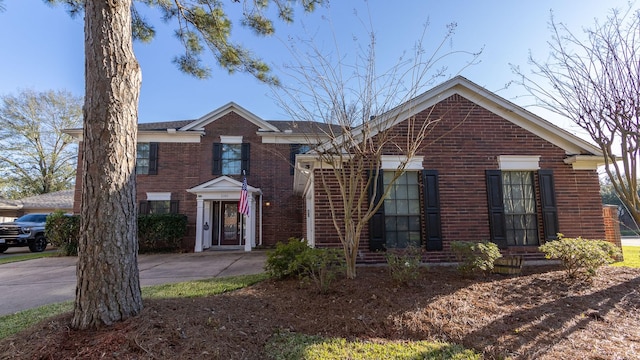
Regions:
[[0, 266, 640, 359]]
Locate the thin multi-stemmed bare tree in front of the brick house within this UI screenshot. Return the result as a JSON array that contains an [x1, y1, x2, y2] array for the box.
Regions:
[[275, 20, 480, 279]]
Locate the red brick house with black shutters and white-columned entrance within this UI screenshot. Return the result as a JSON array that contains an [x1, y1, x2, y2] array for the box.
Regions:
[[69, 77, 605, 262]]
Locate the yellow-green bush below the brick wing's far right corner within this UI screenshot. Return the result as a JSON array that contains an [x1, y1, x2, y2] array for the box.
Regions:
[[540, 234, 622, 278]]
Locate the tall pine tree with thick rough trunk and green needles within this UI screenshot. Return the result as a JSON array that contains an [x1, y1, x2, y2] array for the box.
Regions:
[[44, 0, 323, 329]]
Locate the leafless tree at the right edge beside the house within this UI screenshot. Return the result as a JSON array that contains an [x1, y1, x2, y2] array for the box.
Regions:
[[513, 5, 640, 229]]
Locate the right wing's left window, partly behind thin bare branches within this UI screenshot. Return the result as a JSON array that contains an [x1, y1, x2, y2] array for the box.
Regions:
[[383, 171, 421, 248]]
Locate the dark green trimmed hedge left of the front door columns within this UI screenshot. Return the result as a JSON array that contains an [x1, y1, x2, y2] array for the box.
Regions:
[[138, 214, 187, 254]]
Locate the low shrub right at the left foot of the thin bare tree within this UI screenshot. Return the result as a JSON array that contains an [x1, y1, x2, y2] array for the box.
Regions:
[[291, 247, 345, 294]]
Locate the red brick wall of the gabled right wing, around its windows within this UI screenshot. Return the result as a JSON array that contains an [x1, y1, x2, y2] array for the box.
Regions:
[[315, 95, 605, 261]]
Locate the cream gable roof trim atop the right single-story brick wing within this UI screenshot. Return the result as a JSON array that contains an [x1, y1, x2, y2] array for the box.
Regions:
[[338, 76, 603, 156]]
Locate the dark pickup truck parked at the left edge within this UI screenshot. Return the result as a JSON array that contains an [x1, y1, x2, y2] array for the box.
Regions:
[[0, 214, 49, 254]]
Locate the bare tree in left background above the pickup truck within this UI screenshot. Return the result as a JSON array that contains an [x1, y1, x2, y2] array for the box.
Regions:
[[0, 90, 82, 199]]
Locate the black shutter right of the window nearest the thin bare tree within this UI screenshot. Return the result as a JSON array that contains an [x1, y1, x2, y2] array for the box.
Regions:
[[422, 170, 442, 250]]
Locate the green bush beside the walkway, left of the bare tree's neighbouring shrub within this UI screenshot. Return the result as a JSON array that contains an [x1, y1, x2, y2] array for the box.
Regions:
[[265, 237, 309, 279]]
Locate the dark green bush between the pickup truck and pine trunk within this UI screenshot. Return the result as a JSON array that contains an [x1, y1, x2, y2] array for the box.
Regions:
[[44, 210, 80, 256]]
